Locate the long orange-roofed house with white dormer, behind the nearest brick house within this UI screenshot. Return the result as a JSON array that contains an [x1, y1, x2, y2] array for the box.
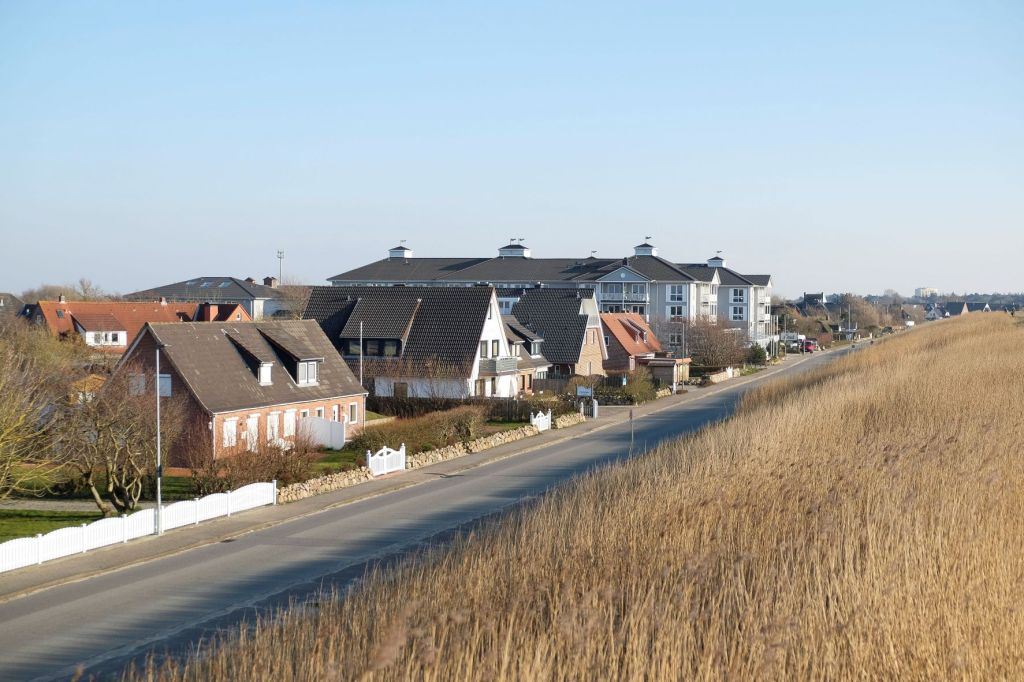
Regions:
[[27, 296, 250, 353]]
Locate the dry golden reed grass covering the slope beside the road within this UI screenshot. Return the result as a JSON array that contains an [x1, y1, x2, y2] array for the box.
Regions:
[[128, 313, 1024, 680]]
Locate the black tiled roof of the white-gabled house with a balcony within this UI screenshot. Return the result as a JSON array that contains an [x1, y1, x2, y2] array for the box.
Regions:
[[303, 287, 494, 377]]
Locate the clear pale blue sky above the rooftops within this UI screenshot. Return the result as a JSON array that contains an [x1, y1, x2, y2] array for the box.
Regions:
[[0, 0, 1024, 295]]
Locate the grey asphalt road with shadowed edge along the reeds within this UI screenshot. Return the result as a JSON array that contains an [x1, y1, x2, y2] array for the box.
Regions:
[[0, 351, 845, 682]]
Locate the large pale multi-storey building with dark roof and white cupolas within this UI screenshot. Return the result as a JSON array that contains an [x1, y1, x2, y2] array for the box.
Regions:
[[329, 242, 772, 348]]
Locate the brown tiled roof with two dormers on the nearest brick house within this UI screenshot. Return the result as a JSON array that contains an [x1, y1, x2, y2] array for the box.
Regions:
[[137, 319, 366, 413]]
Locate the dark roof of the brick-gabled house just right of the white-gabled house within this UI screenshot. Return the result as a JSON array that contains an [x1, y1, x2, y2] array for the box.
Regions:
[[512, 289, 594, 365]]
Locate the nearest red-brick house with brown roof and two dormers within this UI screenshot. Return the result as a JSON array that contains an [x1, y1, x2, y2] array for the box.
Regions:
[[115, 319, 367, 466]]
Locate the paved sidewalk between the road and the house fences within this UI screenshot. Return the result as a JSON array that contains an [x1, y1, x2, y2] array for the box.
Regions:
[[0, 350, 815, 602]]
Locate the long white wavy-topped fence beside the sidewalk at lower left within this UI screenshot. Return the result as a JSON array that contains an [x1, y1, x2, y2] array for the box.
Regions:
[[0, 481, 278, 572]]
